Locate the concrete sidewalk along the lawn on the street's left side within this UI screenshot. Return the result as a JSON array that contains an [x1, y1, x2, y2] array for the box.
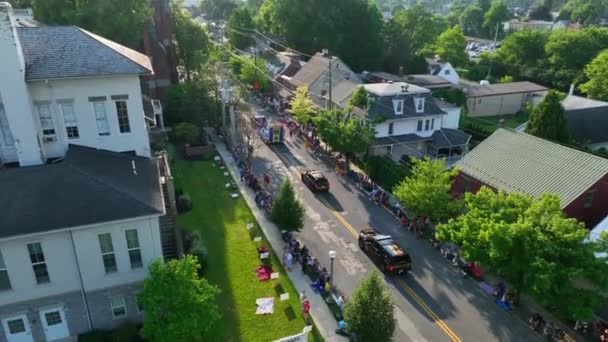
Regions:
[[214, 141, 347, 342]]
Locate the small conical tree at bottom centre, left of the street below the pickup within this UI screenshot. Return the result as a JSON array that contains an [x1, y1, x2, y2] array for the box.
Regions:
[[344, 271, 396, 342]]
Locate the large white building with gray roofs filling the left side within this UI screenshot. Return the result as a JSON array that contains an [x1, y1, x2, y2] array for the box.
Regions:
[[0, 2, 165, 342]]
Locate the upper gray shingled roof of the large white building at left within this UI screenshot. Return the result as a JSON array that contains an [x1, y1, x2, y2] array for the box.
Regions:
[[17, 26, 152, 81]]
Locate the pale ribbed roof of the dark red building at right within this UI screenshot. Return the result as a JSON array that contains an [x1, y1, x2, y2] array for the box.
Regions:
[[456, 128, 608, 208]]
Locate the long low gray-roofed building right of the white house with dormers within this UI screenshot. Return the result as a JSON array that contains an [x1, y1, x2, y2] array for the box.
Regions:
[[460, 81, 549, 117]]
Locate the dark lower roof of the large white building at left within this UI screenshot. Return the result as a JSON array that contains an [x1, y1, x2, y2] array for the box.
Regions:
[[0, 145, 164, 238]]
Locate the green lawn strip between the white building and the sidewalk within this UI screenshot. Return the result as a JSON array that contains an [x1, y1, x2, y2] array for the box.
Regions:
[[172, 158, 323, 341]]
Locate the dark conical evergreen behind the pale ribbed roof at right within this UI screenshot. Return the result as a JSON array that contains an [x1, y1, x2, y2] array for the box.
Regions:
[[526, 90, 571, 143]]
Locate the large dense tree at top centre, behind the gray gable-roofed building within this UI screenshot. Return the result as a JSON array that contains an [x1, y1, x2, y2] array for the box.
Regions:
[[256, 0, 383, 71]]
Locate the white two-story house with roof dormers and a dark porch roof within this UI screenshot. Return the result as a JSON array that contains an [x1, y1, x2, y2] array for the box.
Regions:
[[363, 82, 471, 164]]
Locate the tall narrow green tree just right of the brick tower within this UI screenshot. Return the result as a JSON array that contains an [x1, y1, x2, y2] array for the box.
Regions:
[[171, 1, 210, 82]]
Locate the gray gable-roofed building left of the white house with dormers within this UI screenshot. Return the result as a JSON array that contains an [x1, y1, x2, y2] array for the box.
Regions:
[[289, 50, 362, 108]]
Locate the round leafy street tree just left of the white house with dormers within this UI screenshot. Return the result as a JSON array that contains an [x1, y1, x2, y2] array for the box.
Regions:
[[314, 109, 376, 170]]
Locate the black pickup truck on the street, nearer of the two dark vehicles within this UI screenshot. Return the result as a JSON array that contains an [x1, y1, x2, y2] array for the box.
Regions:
[[358, 229, 412, 274]]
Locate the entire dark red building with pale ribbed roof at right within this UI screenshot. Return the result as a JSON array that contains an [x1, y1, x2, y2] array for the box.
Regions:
[[452, 128, 608, 228]]
